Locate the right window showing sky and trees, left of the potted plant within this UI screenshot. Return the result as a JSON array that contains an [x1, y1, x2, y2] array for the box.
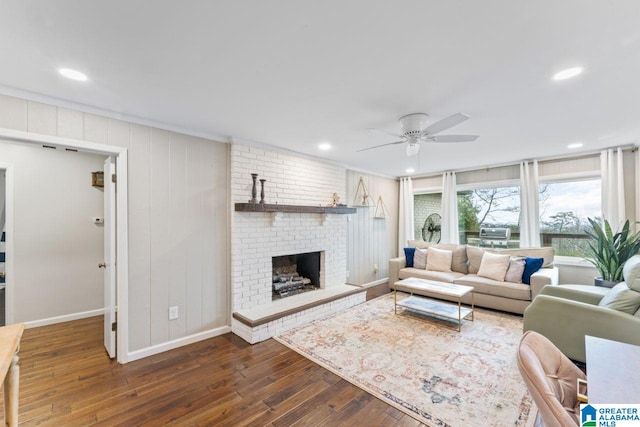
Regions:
[[540, 178, 602, 257]]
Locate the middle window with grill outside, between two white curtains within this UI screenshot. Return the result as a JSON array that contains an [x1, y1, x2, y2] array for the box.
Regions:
[[458, 186, 520, 247]]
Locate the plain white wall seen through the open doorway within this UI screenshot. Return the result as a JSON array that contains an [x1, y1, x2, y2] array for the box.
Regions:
[[0, 141, 105, 322]]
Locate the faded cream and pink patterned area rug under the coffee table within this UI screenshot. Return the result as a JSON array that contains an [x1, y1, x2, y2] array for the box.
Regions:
[[275, 293, 536, 426]]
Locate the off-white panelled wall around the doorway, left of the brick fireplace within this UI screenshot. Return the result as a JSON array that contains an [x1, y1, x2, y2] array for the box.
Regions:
[[0, 95, 230, 351]]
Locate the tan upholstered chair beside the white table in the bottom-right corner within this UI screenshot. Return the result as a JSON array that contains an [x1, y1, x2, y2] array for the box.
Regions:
[[518, 331, 585, 427]]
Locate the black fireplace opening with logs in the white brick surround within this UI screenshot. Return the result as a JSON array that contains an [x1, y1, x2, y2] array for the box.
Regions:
[[271, 252, 320, 300]]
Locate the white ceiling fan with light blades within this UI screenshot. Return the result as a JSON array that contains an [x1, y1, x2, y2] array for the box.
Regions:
[[358, 113, 478, 156]]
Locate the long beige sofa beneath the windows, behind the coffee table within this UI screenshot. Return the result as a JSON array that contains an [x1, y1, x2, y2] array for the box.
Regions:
[[389, 240, 558, 314]]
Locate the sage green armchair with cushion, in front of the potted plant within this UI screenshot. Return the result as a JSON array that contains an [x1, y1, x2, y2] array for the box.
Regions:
[[523, 255, 640, 362]]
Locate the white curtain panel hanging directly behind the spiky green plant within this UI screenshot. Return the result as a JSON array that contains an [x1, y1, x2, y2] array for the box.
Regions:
[[600, 147, 625, 230]]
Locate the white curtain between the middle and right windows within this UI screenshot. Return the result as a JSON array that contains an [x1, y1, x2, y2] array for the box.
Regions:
[[520, 160, 540, 248]]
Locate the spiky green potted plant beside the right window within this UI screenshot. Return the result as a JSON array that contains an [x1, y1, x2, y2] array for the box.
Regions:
[[585, 218, 640, 288]]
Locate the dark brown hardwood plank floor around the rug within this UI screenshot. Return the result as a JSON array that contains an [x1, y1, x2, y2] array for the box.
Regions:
[[7, 290, 421, 426]]
